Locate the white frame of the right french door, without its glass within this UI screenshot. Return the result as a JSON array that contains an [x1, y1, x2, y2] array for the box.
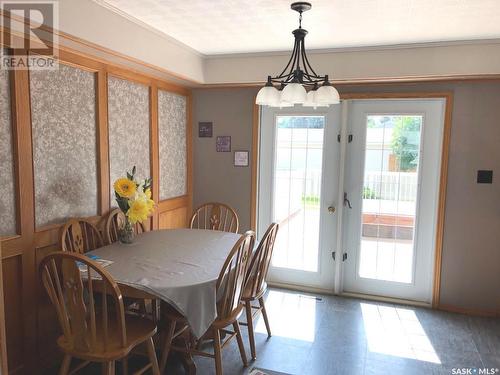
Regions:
[[342, 99, 445, 303]]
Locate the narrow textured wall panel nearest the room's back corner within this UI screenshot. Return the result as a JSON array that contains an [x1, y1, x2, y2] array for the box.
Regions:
[[158, 90, 187, 200]]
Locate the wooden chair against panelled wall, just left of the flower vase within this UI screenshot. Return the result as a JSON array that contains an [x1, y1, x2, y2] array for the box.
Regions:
[[61, 219, 104, 254]]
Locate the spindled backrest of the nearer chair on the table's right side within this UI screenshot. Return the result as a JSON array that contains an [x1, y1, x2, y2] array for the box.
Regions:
[[216, 231, 255, 319]]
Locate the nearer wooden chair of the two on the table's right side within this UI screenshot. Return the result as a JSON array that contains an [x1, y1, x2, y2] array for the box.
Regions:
[[160, 231, 255, 375]]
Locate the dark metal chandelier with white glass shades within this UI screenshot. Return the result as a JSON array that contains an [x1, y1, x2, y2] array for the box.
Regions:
[[255, 1, 340, 108]]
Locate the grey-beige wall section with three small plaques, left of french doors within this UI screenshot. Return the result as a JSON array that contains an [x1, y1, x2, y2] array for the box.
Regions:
[[193, 88, 256, 232]]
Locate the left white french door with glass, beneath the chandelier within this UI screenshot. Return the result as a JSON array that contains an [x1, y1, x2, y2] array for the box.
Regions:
[[257, 106, 340, 291]]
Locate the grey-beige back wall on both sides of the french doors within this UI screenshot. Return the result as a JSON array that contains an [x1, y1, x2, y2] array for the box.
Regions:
[[193, 81, 500, 312]]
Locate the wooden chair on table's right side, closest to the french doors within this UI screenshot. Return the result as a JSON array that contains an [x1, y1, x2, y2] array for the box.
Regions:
[[241, 223, 279, 359]]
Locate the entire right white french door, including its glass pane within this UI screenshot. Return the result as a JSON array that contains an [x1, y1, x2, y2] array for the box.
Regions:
[[343, 99, 444, 302]]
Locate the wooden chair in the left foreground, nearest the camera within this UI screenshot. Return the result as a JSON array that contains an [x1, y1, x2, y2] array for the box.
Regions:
[[40, 251, 160, 375]]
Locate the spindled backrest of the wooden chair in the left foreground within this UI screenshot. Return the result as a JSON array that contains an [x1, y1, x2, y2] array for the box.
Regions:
[[40, 251, 127, 352]]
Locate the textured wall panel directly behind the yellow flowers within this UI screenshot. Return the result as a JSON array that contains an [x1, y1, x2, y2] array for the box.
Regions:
[[108, 77, 151, 206]]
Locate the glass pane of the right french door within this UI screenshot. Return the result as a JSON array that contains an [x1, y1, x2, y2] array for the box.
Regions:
[[359, 115, 423, 283]]
